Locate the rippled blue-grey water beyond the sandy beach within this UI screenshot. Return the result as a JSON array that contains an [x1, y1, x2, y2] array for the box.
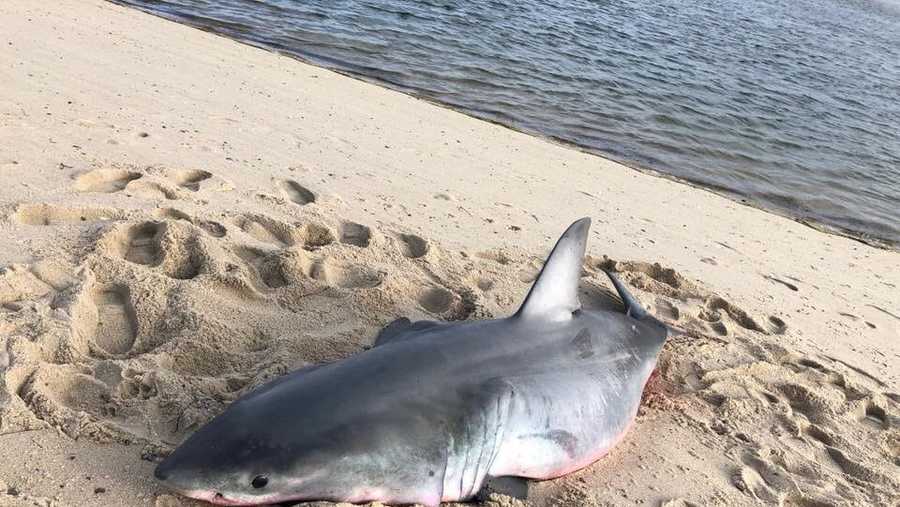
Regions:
[[112, 0, 900, 246]]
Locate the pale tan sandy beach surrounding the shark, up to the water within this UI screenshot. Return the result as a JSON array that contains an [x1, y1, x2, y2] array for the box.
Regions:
[[0, 0, 900, 506]]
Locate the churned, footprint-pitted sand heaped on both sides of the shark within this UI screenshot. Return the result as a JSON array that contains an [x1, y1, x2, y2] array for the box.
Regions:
[[0, 167, 900, 506]]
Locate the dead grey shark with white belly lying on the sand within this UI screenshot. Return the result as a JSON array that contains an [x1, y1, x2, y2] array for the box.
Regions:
[[155, 218, 667, 506]]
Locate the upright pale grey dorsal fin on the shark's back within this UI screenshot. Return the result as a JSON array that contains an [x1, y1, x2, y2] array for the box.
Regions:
[[515, 218, 591, 320]]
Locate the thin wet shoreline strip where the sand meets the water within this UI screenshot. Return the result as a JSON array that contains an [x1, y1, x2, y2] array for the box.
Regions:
[[107, 0, 900, 252]]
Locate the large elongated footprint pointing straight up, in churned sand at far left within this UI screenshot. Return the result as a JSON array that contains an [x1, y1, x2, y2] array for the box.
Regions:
[[93, 286, 137, 355]]
